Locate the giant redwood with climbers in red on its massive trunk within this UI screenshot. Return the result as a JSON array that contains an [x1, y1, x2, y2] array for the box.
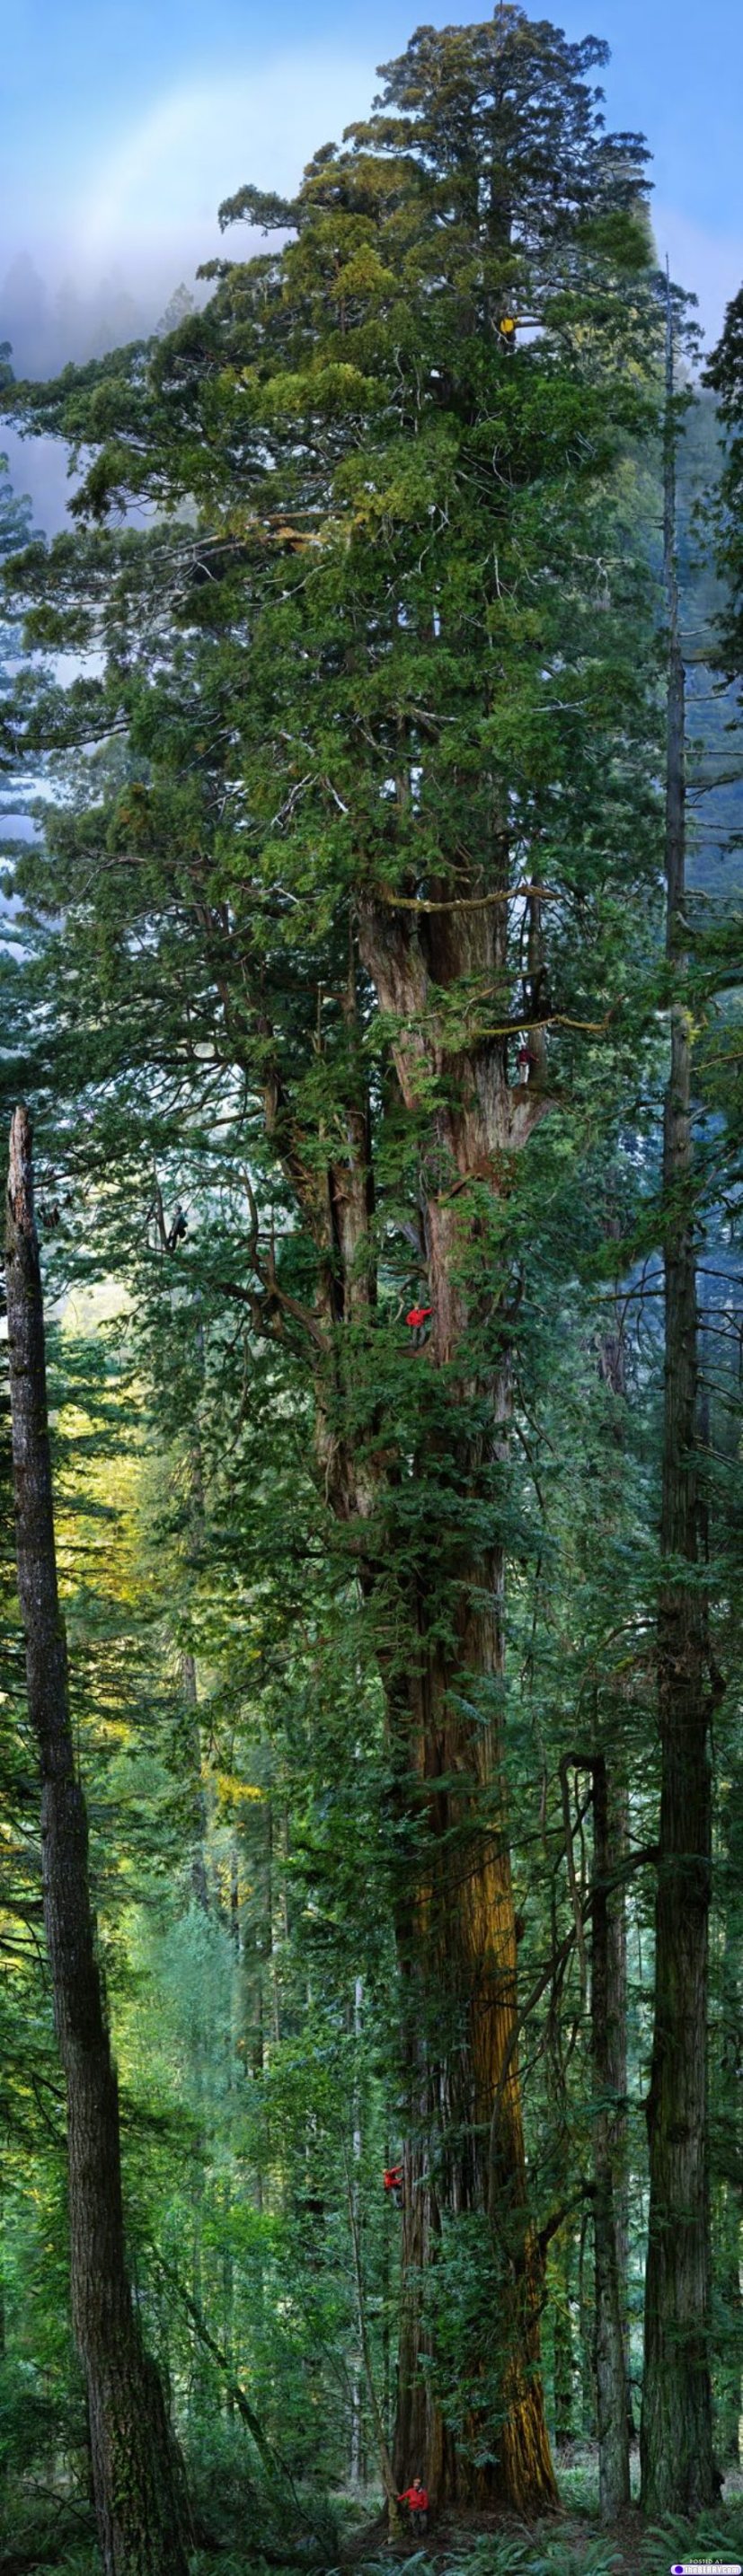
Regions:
[[8, 8, 658, 2511]]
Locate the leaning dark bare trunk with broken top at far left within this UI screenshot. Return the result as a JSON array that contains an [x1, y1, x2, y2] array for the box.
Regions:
[[8, 1108, 189, 2576]]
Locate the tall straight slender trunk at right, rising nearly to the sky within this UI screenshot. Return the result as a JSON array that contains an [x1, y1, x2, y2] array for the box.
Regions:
[[640, 291, 714, 2514]]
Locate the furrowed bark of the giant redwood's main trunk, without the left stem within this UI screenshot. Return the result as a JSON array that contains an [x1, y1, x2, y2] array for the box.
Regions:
[[358, 896, 557, 2511]]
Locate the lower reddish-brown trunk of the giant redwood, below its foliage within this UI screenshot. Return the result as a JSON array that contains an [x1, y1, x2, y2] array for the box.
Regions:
[[392, 1559, 554, 2514]]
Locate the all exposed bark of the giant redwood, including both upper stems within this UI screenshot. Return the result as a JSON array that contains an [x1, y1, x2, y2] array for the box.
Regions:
[[255, 891, 557, 2511]]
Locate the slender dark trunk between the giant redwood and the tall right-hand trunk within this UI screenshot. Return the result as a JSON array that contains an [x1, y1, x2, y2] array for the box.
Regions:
[[591, 1754, 630, 2522]]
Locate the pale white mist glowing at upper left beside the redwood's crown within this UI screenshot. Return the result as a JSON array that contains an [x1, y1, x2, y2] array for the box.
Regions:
[[0, 44, 376, 533]]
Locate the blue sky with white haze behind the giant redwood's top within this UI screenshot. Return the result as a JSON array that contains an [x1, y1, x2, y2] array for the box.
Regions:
[[0, 0, 743, 353]]
